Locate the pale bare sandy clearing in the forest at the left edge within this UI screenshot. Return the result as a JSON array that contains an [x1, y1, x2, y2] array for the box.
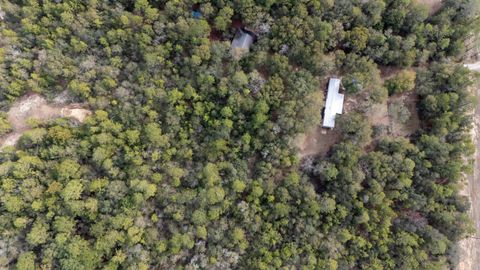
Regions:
[[0, 93, 91, 148]]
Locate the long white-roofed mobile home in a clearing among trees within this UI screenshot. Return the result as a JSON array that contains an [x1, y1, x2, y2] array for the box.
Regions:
[[323, 78, 345, 128]]
